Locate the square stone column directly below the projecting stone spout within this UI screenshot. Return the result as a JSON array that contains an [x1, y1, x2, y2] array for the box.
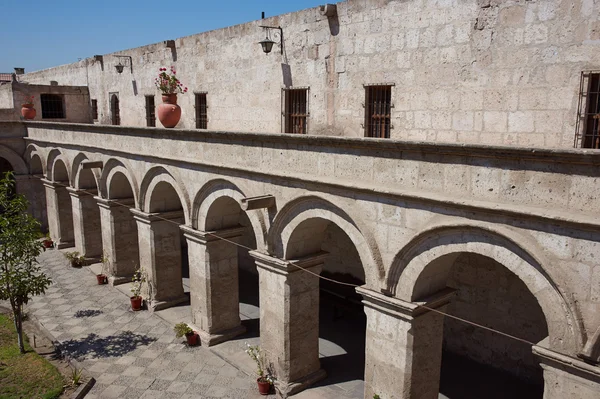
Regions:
[[250, 251, 327, 397]]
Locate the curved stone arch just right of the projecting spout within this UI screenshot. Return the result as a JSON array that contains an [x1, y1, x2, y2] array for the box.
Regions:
[[267, 196, 384, 287]]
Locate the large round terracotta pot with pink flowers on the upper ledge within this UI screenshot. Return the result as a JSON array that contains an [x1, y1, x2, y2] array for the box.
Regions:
[[154, 66, 187, 128]]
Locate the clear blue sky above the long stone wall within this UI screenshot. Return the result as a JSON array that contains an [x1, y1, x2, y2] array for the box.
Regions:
[[0, 0, 326, 72]]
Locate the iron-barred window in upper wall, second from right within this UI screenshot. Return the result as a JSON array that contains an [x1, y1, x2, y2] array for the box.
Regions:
[[365, 85, 392, 138]]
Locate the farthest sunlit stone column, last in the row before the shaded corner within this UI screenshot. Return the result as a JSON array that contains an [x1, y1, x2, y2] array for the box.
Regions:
[[42, 179, 73, 249]]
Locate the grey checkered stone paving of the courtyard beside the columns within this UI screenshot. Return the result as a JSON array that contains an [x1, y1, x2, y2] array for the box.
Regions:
[[28, 250, 275, 399]]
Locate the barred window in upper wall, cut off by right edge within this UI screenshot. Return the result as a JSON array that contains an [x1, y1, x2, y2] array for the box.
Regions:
[[575, 71, 600, 149]]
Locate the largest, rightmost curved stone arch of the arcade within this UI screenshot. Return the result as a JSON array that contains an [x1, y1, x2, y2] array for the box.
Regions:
[[387, 224, 582, 353]]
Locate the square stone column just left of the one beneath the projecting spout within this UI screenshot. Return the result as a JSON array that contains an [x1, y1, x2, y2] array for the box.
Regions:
[[181, 226, 246, 346]]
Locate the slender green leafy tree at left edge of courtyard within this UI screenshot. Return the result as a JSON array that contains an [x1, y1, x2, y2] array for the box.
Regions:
[[0, 172, 51, 353]]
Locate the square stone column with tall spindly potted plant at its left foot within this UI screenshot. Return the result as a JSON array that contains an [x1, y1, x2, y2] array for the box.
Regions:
[[130, 209, 188, 310]]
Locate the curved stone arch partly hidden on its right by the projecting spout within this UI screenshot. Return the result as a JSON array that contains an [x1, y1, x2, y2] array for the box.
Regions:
[[192, 179, 266, 251]]
